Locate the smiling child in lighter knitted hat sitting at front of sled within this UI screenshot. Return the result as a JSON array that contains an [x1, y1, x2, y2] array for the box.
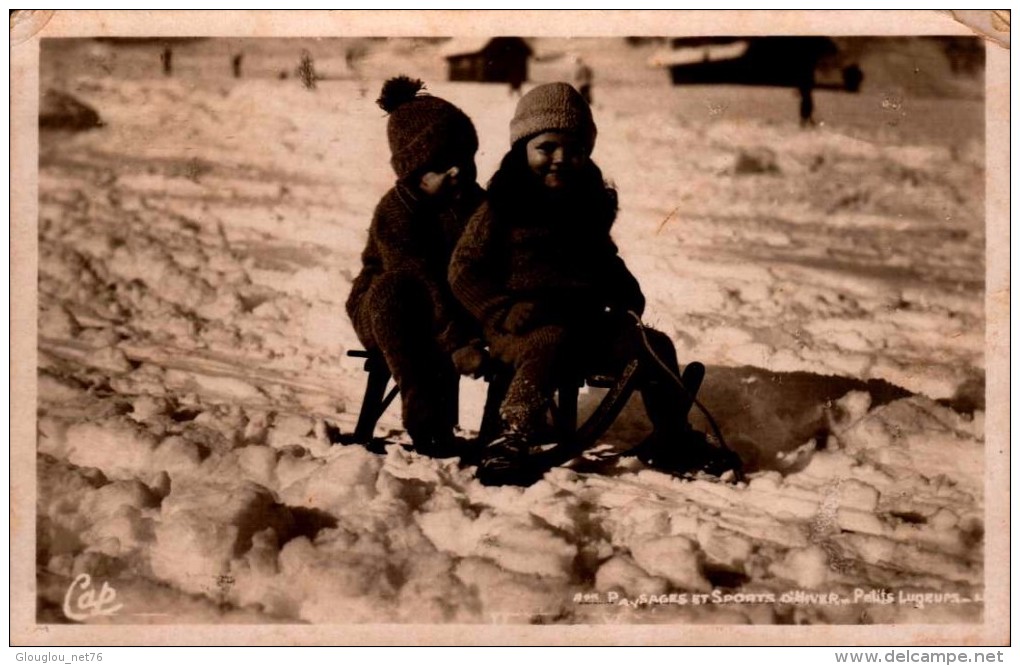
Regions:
[[450, 84, 734, 484]]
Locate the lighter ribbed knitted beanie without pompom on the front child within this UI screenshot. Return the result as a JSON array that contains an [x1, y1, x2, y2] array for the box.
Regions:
[[510, 84, 597, 154]]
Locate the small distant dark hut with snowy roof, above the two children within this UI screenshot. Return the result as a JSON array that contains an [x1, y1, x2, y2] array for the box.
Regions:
[[442, 37, 532, 86]]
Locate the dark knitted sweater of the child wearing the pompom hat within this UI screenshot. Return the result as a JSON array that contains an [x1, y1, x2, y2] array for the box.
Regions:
[[347, 179, 485, 353]]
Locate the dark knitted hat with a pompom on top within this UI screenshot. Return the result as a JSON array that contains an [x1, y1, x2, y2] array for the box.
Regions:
[[376, 76, 478, 178]]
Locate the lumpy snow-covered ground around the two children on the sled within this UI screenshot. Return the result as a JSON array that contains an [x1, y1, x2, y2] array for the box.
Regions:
[[37, 41, 985, 624]]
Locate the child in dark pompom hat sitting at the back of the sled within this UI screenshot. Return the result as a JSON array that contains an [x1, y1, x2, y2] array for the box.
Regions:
[[347, 76, 486, 457]]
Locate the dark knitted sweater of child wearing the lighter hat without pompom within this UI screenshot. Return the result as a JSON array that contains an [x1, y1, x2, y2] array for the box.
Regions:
[[450, 193, 645, 331]]
